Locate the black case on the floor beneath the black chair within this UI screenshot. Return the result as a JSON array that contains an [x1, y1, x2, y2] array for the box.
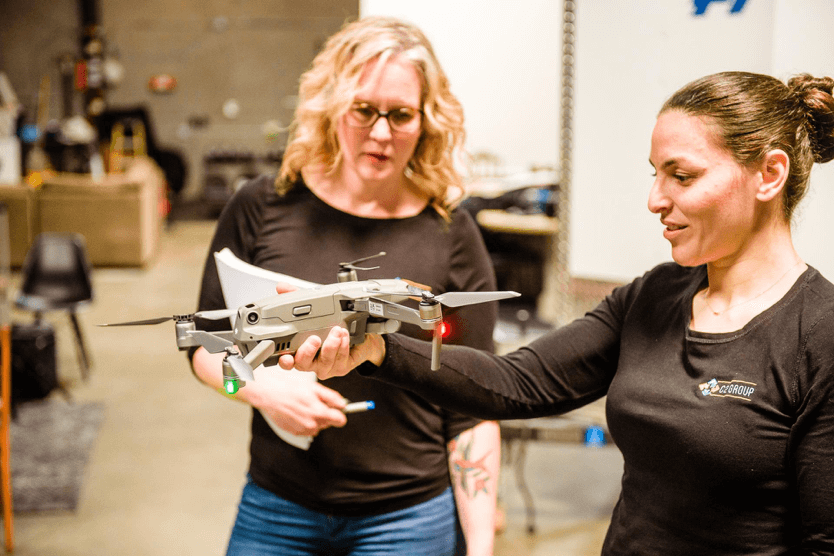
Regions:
[[12, 323, 58, 403]]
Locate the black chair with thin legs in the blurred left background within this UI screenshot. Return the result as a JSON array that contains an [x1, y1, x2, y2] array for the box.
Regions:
[[15, 232, 93, 380]]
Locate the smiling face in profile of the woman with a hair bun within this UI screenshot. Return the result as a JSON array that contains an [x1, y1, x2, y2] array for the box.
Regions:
[[649, 110, 760, 266]]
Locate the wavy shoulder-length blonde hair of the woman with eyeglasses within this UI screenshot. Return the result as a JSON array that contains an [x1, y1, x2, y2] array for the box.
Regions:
[[275, 17, 465, 218]]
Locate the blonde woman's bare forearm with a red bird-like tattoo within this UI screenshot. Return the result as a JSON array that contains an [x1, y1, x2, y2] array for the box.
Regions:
[[449, 421, 501, 556]]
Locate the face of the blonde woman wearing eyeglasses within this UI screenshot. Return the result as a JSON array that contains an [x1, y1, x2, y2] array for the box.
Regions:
[[337, 56, 422, 185]]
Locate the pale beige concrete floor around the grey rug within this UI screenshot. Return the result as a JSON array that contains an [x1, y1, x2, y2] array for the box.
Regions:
[[4, 222, 622, 556]]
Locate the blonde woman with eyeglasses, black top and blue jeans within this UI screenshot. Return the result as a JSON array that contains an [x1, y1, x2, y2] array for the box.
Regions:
[[192, 17, 500, 556]]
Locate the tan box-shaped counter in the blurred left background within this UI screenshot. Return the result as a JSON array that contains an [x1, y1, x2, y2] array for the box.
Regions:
[[38, 162, 164, 266]]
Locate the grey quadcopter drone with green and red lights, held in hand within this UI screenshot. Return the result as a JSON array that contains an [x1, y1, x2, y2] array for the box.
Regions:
[[99, 251, 521, 395]]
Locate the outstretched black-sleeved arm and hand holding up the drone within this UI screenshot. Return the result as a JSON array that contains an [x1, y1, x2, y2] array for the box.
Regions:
[[281, 302, 620, 419]]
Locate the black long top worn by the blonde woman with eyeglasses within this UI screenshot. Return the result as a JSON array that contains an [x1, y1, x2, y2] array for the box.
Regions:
[[192, 176, 497, 515]]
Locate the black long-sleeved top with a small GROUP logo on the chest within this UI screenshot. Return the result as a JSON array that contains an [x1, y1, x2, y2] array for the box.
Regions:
[[368, 264, 834, 556]]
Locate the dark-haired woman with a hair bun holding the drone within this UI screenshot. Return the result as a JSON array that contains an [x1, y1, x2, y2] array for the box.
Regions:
[[290, 72, 834, 556]]
